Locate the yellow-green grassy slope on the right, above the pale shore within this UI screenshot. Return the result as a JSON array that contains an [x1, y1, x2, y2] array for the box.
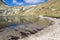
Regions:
[[24, 0, 60, 17]]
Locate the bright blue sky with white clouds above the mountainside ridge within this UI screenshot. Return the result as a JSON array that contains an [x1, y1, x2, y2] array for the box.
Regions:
[[3, 0, 48, 6]]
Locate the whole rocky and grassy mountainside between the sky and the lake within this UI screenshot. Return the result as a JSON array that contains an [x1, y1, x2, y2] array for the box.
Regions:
[[0, 0, 60, 17]]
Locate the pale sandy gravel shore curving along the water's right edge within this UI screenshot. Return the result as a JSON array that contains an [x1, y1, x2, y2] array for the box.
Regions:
[[19, 17, 60, 40]]
